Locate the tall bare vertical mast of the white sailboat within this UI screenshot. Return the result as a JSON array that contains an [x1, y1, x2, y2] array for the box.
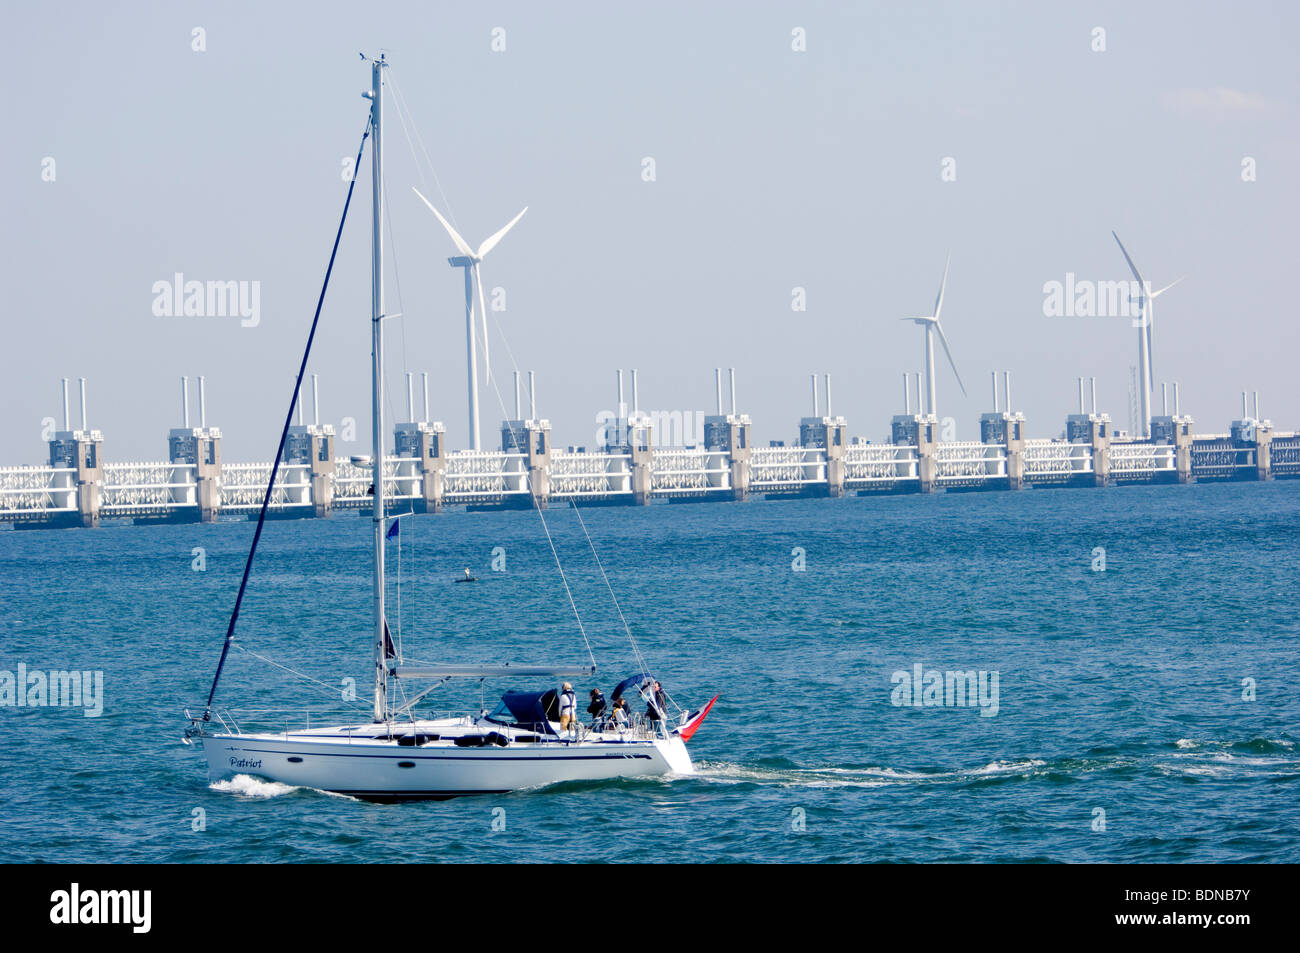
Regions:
[[368, 53, 389, 722]]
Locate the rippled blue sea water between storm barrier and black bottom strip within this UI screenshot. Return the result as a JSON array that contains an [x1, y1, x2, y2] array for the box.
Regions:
[[0, 482, 1300, 862]]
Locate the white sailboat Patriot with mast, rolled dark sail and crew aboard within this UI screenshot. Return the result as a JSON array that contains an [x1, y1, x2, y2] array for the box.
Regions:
[[185, 55, 716, 801]]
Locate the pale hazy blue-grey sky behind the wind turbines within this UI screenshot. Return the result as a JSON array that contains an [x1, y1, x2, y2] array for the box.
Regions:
[[0, 1, 1300, 464]]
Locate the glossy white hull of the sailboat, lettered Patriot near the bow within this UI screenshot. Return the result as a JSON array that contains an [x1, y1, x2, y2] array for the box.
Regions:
[[203, 729, 694, 801]]
